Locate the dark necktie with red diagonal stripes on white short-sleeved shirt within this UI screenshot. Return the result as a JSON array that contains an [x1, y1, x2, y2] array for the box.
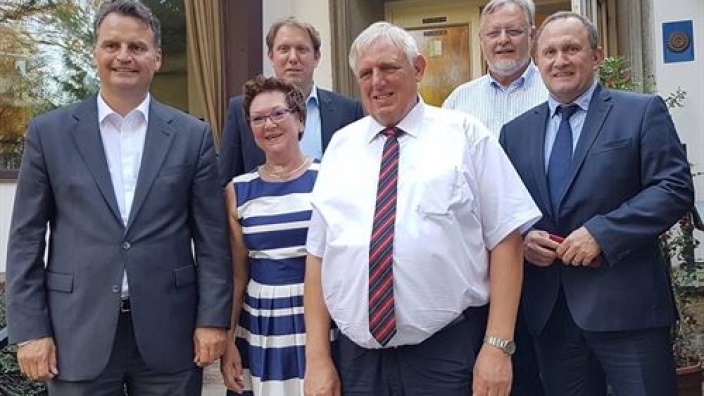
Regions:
[[369, 128, 401, 346]]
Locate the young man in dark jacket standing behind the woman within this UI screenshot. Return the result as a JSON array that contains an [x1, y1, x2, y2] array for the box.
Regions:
[[218, 18, 364, 185]]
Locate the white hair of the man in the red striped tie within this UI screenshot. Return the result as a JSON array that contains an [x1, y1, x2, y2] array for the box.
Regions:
[[349, 22, 420, 72]]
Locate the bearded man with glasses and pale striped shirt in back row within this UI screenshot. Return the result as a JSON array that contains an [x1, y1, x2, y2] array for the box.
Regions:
[[442, 0, 548, 396]]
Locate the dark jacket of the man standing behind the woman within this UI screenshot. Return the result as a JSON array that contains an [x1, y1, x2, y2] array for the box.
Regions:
[[218, 88, 364, 185]]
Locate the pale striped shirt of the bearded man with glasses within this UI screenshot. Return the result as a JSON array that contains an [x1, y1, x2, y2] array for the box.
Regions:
[[442, 62, 548, 137]]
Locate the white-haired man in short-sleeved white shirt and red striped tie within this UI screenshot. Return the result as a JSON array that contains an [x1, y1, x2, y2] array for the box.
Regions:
[[304, 22, 540, 396]]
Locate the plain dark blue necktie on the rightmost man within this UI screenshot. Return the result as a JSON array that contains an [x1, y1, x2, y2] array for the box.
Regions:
[[548, 105, 579, 214]]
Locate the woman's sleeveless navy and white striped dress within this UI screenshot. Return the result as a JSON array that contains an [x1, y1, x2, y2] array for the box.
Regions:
[[228, 161, 319, 396]]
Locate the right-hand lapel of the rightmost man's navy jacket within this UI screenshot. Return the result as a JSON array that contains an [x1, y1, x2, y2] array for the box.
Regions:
[[561, 85, 613, 201]]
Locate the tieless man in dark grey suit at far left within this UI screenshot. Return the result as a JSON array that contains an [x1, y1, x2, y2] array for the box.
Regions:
[[7, 1, 232, 396]]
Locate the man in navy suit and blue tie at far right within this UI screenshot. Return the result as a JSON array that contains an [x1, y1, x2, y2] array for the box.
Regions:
[[500, 12, 694, 396]]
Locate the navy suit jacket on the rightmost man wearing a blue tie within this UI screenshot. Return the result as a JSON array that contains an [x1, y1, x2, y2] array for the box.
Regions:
[[500, 88, 694, 334]]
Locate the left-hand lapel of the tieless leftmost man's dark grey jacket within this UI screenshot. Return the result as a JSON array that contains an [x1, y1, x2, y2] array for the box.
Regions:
[[70, 95, 122, 225]]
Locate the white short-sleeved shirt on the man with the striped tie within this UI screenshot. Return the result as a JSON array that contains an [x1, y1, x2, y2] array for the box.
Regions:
[[306, 101, 540, 348]]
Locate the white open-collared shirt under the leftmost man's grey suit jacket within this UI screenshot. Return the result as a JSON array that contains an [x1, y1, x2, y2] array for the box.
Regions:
[[98, 94, 151, 298]]
